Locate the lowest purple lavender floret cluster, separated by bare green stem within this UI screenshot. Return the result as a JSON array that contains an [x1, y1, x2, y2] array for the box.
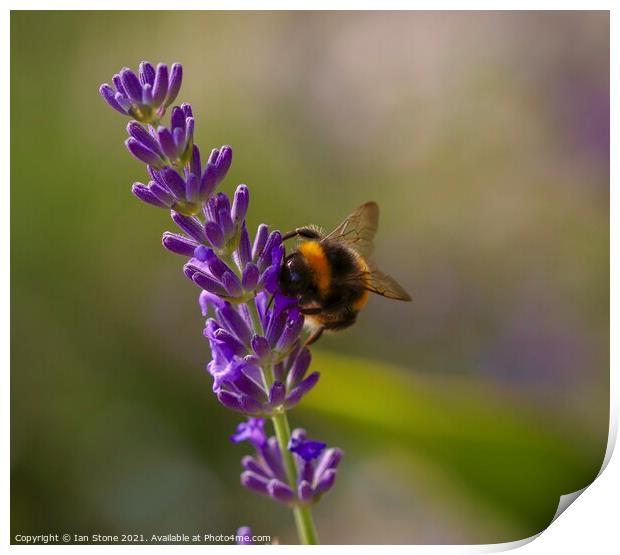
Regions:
[[231, 418, 343, 505]]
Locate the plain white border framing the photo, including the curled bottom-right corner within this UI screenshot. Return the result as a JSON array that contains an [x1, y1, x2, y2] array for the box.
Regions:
[[0, 0, 620, 555]]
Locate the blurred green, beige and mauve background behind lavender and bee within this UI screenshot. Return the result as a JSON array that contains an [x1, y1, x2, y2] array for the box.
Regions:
[[11, 12, 609, 543]]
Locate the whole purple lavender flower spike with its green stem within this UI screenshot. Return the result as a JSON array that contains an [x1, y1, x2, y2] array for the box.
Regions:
[[99, 62, 342, 544]]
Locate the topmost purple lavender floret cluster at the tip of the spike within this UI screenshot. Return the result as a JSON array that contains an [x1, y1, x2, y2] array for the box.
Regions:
[[99, 62, 183, 124]]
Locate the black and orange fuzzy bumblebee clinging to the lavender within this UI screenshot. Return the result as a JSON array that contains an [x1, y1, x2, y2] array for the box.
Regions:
[[280, 202, 411, 345]]
